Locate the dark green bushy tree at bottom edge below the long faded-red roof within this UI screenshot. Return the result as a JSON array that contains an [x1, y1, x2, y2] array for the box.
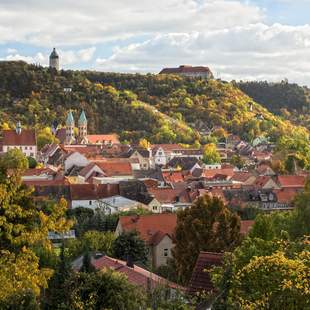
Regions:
[[66, 270, 146, 310]]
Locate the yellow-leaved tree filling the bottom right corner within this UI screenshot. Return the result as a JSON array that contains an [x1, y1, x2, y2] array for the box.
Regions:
[[232, 252, 310, 309]]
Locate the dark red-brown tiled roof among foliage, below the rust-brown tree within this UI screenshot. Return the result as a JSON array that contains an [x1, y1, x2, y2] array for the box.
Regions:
[[188, 252, 223, 294]]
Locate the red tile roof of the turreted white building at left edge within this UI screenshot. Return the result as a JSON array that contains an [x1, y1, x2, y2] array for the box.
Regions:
[[3, 129, 37, 146]]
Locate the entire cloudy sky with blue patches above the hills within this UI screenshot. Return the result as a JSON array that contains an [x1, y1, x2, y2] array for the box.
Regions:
[[0, 0, 310, 85]]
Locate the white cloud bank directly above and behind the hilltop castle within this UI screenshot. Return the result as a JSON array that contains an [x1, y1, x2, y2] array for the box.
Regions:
[[96, 24, 310, 85]]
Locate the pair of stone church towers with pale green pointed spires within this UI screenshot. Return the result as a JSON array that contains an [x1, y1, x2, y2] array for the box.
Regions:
[[65, 111, 87, 144]]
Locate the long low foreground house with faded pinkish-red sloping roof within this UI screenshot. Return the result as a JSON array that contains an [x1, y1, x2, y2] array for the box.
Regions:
[[72, 253, 182, 293]]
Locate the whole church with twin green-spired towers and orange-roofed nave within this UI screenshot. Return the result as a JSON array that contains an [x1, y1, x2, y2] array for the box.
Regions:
[[54, 110, 120, 146]]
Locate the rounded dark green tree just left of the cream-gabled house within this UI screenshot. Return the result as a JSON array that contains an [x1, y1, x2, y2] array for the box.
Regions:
[[113, 231, 148, 264]]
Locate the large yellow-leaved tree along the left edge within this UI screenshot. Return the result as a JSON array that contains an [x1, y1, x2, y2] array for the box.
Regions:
[[0, 150, 71, 302]]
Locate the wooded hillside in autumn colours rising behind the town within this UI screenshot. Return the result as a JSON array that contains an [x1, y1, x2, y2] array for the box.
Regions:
[[0, 62, 309, 167]]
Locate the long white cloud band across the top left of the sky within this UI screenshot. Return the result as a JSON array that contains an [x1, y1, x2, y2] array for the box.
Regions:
[[0, 0, 262, 47]]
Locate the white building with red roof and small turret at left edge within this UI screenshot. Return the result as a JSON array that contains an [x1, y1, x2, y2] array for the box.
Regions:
[[2, 122, 38, 158]]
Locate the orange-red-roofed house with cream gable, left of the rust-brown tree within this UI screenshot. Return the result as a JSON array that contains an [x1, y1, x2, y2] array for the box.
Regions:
[[115, 213, 176, 268]]
